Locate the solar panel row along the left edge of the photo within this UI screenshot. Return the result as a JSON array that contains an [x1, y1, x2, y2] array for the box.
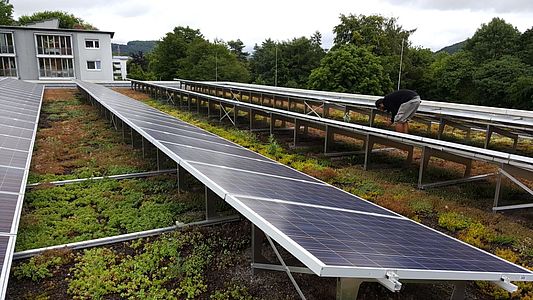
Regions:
[[0, 78, 43, 299]]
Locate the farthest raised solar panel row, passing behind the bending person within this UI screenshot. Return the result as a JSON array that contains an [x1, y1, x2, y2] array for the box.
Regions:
[[172, 79, 533, 152]]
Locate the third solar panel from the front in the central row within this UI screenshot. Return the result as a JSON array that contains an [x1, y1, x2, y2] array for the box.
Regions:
[[164, 143, 319, 182]]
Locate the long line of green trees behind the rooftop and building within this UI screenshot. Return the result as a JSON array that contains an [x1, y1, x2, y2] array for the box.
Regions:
[[0, 0, 533, 109]]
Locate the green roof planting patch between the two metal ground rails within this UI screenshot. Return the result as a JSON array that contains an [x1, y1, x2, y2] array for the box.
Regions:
[[16, 176, 203, 251]]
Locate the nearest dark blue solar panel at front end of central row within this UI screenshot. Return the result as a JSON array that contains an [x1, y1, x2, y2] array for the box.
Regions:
[[238, 197, 528, 273]]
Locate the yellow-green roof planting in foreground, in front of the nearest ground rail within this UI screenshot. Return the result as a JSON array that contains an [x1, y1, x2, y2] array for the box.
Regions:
[[14, 228, 253, 299]]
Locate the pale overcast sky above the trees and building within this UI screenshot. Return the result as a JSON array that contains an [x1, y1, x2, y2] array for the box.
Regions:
[[10, 0, 533, 50]]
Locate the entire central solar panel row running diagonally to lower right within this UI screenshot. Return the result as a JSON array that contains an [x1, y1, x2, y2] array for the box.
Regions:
[[77, 81, 533, 281]]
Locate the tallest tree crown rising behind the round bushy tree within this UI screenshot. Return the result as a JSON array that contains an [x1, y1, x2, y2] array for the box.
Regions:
[[332, 14, 415, 56]]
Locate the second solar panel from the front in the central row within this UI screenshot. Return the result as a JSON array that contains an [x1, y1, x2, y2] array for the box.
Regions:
[[190, 163, 393, 215]]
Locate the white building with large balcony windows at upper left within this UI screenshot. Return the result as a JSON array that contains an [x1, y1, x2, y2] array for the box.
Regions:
[[0, 20, 113, 81]]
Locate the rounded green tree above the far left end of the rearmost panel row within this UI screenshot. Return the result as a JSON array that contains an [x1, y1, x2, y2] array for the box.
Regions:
[[176, 39, 250, 82]]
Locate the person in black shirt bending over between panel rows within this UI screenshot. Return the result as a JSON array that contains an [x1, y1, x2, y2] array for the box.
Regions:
[[376, 90, 421, 133]]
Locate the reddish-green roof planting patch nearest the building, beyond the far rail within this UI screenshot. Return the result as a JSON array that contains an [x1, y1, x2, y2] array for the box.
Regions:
[[29, 89, 153, 183]]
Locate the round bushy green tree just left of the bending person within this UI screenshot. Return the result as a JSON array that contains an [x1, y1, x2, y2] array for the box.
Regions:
[[309, 45, 392, 95]]
